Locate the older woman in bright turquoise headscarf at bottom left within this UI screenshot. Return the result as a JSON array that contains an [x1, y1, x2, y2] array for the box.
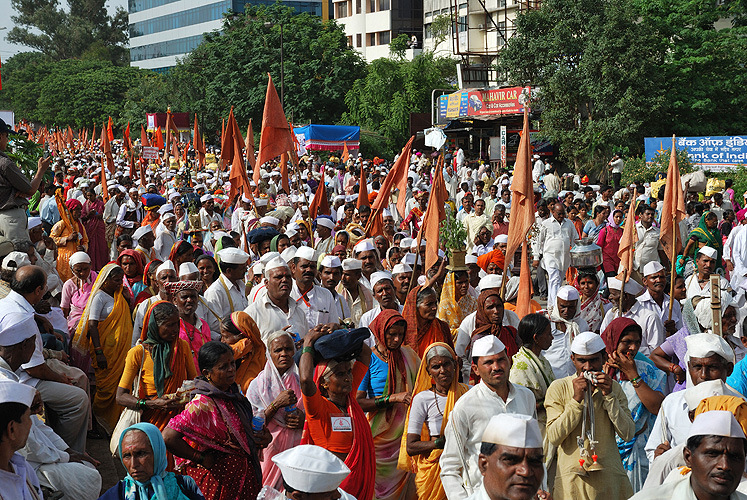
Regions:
[[99, 422, 205, 500]]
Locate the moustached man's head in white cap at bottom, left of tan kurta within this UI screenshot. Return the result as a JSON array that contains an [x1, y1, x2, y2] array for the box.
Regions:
[[469, 413, 549, 500]]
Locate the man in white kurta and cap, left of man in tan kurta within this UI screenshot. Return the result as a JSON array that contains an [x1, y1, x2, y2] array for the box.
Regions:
[[439, 335, 536, 500]]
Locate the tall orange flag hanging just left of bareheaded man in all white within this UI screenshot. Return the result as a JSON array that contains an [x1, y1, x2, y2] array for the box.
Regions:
[[505, 107, 535, 269]]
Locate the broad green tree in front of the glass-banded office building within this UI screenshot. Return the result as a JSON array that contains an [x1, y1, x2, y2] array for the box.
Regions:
[[168, 4, 365, 140]]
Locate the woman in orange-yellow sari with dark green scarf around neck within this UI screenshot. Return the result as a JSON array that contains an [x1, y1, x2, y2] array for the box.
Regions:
[[117, 301, 197, 430]]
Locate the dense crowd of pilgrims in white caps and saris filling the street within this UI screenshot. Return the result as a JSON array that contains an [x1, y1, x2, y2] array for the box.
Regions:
[[0, 139, 747, 500]]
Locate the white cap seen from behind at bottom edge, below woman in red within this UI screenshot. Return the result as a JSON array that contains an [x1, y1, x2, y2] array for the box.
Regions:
[[272, 444, 350, 493]]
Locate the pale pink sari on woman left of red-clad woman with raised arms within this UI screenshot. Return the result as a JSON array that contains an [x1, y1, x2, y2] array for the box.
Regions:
[[247, 354, 303, 490]]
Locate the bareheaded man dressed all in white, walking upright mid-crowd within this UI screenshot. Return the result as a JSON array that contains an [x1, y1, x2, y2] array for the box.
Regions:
[[532, 202, 578, 304]]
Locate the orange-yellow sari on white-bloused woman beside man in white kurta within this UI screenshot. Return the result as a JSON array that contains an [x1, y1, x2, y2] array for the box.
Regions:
[[397, 342, 469, 500]]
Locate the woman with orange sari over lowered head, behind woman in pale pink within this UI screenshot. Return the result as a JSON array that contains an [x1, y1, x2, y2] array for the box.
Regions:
[[220, 311, 267, 393]]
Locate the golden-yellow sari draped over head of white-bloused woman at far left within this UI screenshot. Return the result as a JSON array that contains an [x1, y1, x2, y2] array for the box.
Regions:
[[72, 264, 132, 432]]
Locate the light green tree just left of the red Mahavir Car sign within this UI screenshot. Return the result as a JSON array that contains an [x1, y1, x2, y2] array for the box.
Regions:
[[342, 52, 456, 151]]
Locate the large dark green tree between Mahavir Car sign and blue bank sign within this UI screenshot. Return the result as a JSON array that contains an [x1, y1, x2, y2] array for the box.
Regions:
[[498, 0, 665, 176]]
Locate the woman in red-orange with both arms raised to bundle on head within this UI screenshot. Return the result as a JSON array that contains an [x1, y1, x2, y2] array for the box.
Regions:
[[299, 327, 376, 499]]
